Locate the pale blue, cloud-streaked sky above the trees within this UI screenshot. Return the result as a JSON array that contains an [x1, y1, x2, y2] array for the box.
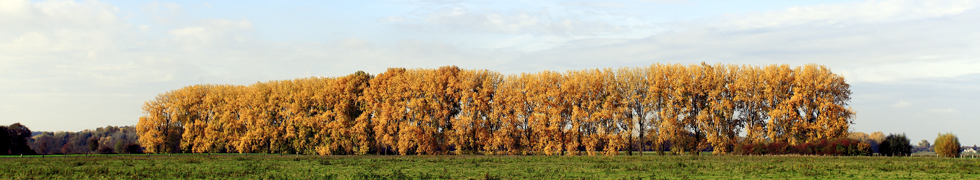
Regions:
[[0, 0, 980, 145]]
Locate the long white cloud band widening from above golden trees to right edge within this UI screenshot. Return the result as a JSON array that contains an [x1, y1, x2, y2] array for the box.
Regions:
[[512, 1, 980, 83]]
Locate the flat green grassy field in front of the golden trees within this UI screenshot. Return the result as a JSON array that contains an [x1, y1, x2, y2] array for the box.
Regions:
[[0, 154, 980, 179]]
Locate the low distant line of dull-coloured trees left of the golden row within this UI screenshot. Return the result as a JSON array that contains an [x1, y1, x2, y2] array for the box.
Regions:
[[30, 126, 142, 154]]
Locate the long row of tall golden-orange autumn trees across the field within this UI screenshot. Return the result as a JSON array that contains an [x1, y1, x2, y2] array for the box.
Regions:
[[137, 64, 854, 155]]
